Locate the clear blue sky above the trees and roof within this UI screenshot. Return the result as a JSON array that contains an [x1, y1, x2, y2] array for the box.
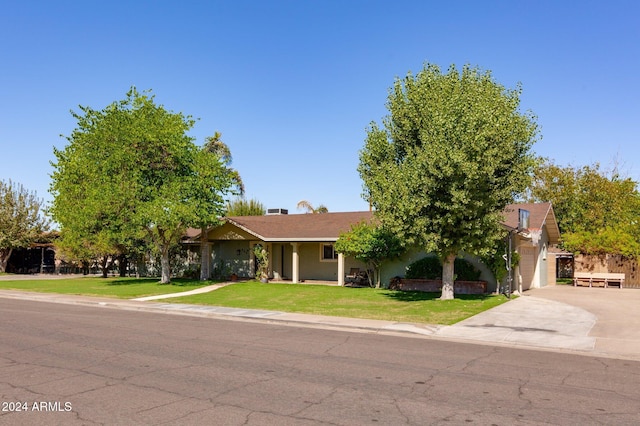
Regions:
[[0, 0, 640, 213]]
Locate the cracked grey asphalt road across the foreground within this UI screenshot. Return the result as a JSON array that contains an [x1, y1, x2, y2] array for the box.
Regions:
[[0, 299, 640, 426]]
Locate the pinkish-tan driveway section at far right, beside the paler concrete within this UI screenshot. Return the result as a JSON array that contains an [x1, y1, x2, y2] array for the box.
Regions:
[[524, 285, 640, 359]]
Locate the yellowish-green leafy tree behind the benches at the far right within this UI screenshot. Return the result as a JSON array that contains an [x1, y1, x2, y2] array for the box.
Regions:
[[528, 159, 640, 257]]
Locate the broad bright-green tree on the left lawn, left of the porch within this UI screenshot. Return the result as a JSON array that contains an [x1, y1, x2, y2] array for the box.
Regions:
[[50, 88, 233, 283]]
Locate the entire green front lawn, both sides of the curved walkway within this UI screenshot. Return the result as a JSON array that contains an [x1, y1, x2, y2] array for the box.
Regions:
[[0, 277, 508, 325]]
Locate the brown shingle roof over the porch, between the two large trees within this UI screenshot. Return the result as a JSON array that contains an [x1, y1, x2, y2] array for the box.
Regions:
[[226, 211, 373, 242]]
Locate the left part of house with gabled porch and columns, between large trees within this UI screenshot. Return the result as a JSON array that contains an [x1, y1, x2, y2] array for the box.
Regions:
[[190, 212, 373, 285]]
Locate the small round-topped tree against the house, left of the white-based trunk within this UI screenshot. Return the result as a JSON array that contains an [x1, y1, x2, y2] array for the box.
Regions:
[[335, 222, 404, 287]]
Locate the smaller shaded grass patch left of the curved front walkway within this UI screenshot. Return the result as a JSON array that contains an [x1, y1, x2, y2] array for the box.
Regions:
[[0, 277, 213, 299]]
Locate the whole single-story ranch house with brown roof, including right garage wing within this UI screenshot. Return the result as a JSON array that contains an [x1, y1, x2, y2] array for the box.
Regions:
[[188, 203, 560, 291]]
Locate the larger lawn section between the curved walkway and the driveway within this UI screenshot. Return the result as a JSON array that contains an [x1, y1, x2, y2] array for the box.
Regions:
[[166, 281, 508, 324]]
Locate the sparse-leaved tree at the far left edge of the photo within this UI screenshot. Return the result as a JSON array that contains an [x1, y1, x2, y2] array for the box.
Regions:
[[0, 181, 49, 272]]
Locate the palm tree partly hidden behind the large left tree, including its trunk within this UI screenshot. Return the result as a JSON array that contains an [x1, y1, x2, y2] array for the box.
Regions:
[[200, 132, 244, 281]]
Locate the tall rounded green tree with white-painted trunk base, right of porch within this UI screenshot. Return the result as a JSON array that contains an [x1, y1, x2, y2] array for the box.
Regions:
[[358, 64, 538, 299]]
